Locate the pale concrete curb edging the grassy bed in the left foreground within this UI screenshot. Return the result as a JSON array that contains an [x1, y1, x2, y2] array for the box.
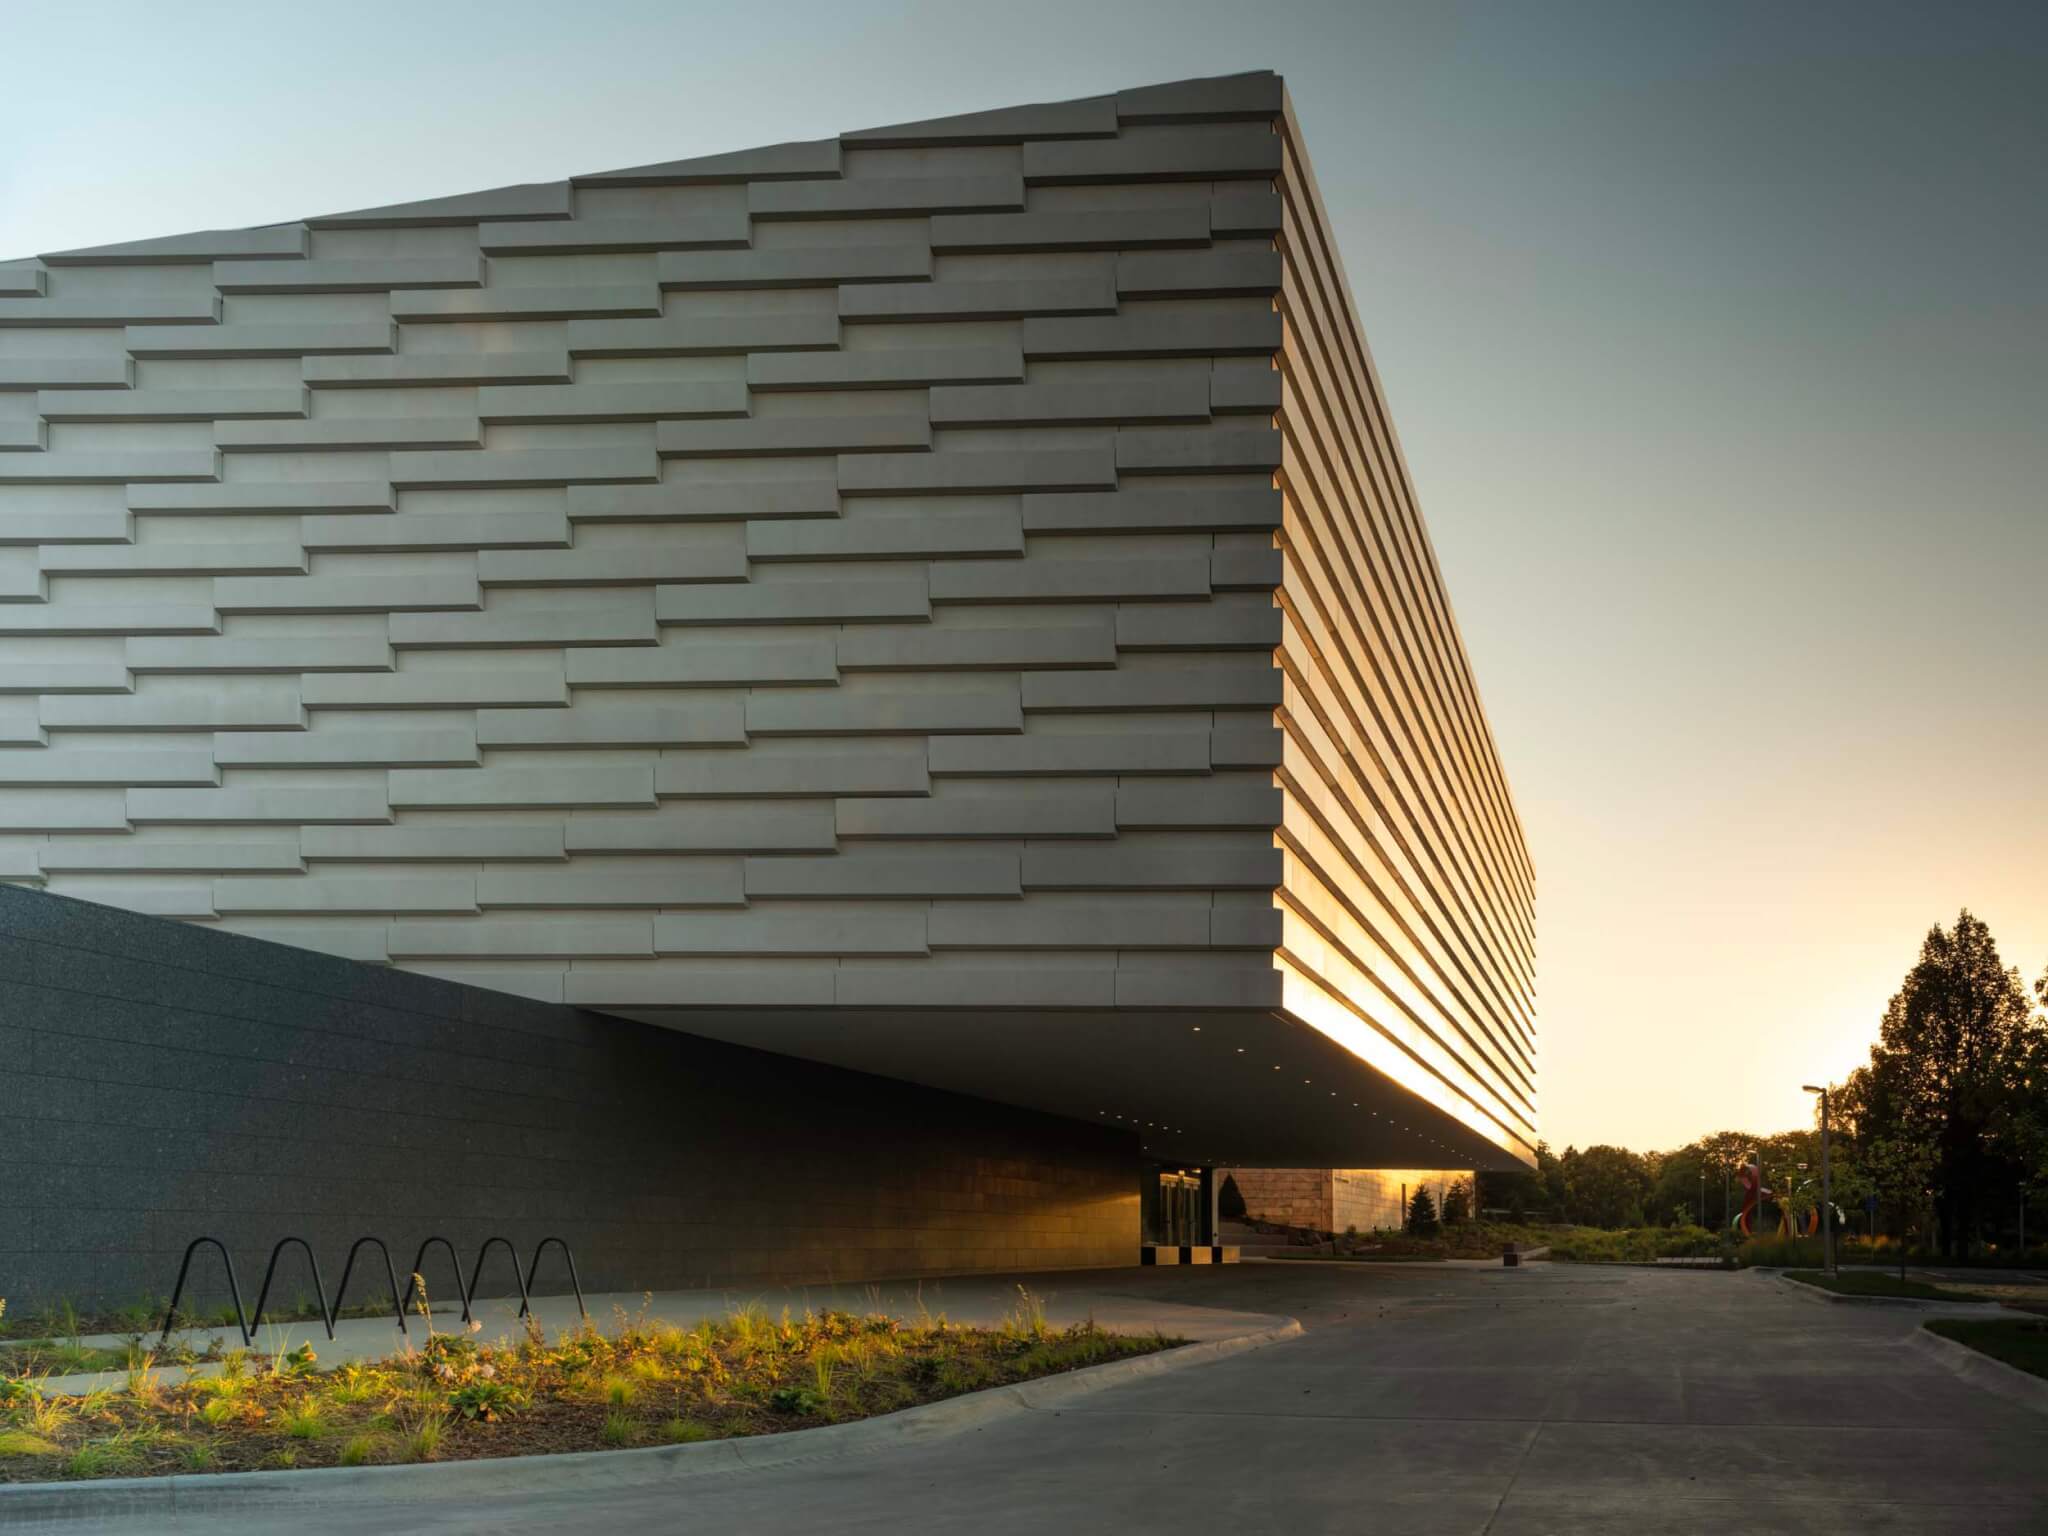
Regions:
[[0, 1317, 1303, 1526]]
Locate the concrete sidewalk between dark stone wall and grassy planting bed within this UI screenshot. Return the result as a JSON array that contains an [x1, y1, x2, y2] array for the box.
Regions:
[[28, 1270, 1286, 1395]]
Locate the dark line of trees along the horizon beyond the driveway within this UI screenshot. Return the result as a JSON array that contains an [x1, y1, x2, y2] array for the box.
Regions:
[[1477, 909, 2048, 1257]]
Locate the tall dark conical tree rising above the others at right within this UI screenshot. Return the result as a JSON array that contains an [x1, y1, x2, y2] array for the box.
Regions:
[[1860, 921, 2040, 1257]]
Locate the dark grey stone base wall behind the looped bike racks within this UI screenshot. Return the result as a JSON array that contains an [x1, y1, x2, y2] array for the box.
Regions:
[[0, 887, 1139, 1315]]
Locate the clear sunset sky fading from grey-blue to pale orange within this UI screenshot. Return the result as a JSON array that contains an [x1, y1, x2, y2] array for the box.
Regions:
[[0, 0, 2048, 1149]]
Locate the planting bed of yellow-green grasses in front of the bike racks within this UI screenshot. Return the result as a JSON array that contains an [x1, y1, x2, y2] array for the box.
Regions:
[[0, 1296, 1182, 1483]]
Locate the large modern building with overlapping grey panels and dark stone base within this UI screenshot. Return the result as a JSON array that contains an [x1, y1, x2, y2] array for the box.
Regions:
[[0, 74, 1536, 1292]]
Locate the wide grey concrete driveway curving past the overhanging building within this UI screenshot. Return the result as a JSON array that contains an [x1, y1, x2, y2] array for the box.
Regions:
[[0, 1264, 2048, 1536]]
